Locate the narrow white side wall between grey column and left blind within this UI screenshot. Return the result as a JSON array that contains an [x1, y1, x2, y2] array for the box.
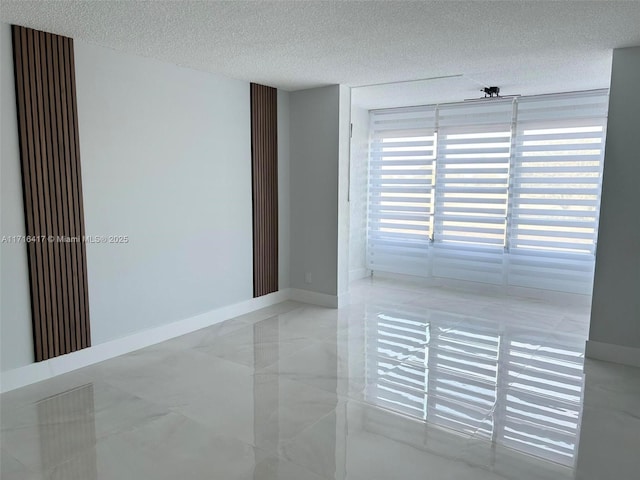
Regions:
[[349, 105, 369, 280]]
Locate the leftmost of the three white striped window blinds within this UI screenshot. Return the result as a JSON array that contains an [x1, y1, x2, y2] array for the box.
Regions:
[[367, 107, 436, 275]]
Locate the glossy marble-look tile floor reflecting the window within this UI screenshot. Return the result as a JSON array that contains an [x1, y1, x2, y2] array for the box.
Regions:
[[0, 279, 640, 480]]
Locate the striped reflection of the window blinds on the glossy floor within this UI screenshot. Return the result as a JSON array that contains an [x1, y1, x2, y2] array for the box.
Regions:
[[365, 307, 584, 467]]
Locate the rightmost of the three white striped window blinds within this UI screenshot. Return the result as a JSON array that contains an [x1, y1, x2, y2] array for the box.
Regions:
[[508, 92, 608, 293]]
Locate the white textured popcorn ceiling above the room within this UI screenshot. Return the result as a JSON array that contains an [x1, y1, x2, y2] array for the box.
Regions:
[[0, 0, 640, 108]]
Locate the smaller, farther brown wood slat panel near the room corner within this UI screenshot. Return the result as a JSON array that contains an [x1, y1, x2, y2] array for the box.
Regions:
[[251, 83, 278, 297]]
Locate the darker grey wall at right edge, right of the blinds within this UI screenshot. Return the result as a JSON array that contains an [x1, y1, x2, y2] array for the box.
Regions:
[[589, 47, 640, 348]]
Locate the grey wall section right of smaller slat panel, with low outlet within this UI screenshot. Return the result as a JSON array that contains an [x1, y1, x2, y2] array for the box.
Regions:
[[290, 85, 340, 295]]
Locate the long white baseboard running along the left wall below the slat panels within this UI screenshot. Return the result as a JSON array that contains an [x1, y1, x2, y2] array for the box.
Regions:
[[0, 289, 290, 392]]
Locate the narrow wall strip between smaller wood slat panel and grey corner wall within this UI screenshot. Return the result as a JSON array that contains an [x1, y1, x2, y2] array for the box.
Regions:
[[278, 90, 291, 290]]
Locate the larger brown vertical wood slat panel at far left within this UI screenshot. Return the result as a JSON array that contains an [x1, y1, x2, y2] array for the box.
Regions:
[[12, 25, 91, 361]]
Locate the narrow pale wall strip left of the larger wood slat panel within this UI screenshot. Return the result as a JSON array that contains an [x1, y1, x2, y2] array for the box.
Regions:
[[0, 23, 34, 371]]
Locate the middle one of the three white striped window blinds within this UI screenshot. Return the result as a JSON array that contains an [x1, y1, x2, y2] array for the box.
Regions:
[[433, 100, 513, 283]]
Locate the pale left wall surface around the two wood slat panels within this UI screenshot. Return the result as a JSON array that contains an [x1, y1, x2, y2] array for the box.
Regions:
[[0, 24, 289, 371]]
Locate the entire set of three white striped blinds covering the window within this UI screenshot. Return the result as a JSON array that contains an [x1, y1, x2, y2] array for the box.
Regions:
[[367, 90, 608, 294]]
